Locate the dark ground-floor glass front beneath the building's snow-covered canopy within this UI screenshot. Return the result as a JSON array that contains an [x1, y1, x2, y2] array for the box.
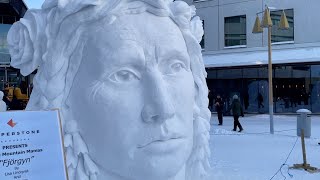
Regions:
[[207, 63, 320, 113]]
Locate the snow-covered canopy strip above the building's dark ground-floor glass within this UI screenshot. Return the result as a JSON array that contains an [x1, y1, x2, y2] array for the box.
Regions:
[[203, 47, 320, 68]]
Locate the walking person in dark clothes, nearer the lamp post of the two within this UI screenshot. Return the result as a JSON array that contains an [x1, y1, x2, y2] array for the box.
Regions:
[[231, 95, 244, 132]]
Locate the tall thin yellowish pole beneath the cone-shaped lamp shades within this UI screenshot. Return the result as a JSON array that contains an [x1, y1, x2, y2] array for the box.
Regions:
[[268, 26, 274, 134]]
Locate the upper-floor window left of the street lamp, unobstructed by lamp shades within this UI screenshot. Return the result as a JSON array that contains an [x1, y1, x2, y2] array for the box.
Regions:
[[224, 15, 247, 47]]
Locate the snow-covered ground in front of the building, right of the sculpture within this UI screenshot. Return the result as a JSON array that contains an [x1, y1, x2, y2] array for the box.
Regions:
[[209, 114, 320, 180]]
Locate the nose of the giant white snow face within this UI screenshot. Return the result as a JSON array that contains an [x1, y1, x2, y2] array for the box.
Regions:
[[141, 72, 175, 124]]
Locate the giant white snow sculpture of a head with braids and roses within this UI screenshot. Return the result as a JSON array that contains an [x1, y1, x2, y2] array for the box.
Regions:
[[8, 0, 210, 180]]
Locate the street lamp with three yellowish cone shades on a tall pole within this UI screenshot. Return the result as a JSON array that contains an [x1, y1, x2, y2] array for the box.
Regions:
[[252, 6, 289, 134]]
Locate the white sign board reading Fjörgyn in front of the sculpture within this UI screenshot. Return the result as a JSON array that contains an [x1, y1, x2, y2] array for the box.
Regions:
[[0, 110, 67, 180]]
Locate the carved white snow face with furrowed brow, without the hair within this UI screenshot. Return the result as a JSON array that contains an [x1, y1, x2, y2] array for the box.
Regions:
[[68, 13, 195, 180]]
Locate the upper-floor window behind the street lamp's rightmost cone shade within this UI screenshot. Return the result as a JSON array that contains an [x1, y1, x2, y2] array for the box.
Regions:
[[270, 9, 294, 43]]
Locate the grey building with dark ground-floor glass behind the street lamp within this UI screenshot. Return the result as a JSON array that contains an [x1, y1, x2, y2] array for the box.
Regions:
[[185, 0, 320, 113]]
